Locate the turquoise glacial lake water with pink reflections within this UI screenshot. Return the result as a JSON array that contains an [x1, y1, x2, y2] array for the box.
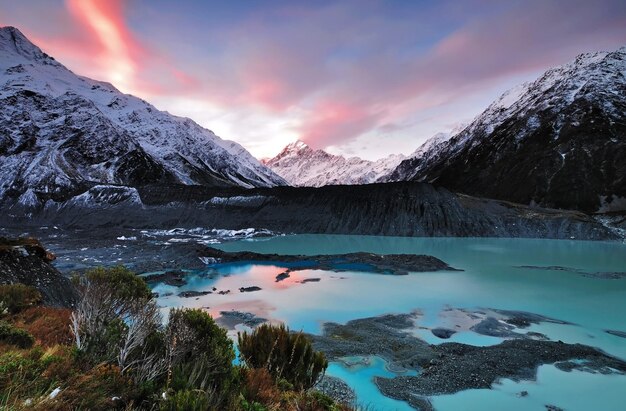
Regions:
[[154, 235, 626, 411]]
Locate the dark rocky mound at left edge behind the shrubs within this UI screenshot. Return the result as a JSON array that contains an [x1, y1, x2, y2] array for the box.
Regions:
[[0, 237, 78, 307]]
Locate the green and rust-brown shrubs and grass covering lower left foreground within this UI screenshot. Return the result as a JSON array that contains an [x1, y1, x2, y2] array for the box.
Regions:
[[0, 267, 349, 411]]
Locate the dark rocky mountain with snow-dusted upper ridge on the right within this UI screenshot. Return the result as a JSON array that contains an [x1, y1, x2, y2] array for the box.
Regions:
[[381, 47, 626, 212]]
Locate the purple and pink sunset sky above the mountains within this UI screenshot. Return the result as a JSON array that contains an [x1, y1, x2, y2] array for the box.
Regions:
[[0, 0, 626, 159]]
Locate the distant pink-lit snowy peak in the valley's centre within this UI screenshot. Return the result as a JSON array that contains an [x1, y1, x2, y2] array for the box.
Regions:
[[263, 141, 405, 187]]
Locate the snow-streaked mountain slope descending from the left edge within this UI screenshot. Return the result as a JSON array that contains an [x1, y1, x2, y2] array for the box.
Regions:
[[0, 27, 286, 208]]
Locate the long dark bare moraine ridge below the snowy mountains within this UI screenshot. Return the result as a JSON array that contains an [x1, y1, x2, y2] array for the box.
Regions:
[[0, 182, 619, 240]]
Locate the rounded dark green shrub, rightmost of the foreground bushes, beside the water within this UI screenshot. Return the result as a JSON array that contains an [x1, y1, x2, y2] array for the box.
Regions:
[[238, 324, 328, 390]]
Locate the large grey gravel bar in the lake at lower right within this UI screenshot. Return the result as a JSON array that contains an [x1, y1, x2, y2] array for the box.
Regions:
[[310, 310, 626, 410]]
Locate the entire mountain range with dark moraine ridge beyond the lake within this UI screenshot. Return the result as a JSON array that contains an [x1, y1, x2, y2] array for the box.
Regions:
[[0, 27, 626, 239]]
